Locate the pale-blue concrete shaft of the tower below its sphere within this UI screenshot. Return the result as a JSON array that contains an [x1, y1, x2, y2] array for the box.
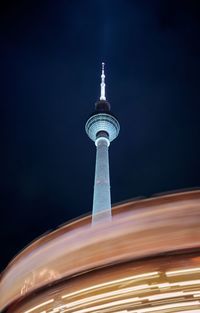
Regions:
[[92, 137, 112, 223]]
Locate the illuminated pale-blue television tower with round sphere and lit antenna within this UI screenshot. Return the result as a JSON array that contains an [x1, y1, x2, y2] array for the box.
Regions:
[[85, 63, 120, 224]]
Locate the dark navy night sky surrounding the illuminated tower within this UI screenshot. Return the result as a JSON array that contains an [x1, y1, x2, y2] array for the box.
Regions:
[[0, 0, 200, 269]]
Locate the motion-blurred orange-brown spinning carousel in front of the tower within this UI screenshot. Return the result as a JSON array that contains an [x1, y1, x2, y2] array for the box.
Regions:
[[0, 191, 200, 313]]
